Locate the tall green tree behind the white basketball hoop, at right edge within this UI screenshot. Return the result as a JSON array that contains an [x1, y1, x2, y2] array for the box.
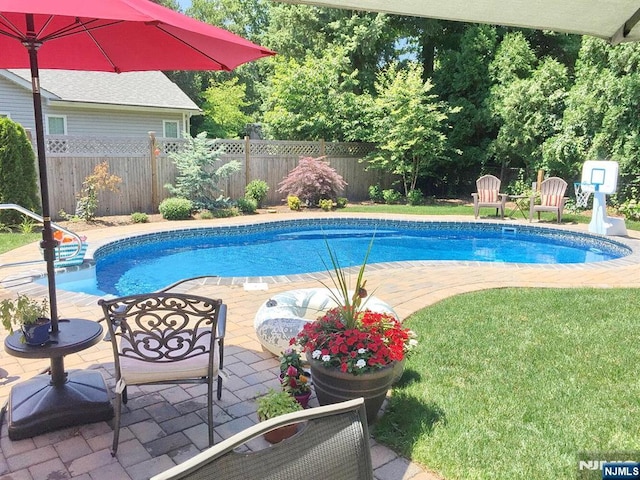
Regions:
[[545, 37, 640, 199]]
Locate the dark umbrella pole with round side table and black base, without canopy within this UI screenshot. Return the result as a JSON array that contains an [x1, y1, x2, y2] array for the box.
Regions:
[[4, 23, 113, 440]]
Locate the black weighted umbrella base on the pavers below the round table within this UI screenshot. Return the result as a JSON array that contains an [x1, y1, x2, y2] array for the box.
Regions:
[[7, 370, 113, 440]]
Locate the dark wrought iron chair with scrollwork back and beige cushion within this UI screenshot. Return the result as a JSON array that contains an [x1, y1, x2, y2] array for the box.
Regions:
[[98, 291, 226, 456]]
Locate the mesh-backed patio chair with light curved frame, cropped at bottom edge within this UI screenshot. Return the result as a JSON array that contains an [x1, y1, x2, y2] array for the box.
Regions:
[[151, 398, 374, 480]]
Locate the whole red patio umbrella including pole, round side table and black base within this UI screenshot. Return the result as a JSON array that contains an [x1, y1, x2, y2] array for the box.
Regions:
[[0, 0, 274, 439]]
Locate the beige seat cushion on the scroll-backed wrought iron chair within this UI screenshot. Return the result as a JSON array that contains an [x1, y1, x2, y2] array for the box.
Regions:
[[120, 329, 219, 385]]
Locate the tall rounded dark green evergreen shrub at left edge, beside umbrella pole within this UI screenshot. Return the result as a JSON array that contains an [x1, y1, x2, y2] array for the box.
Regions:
[[0, 118, 40, 225]]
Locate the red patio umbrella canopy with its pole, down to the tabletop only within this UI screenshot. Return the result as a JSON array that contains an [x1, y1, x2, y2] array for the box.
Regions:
[[0, 0, 274, 326]]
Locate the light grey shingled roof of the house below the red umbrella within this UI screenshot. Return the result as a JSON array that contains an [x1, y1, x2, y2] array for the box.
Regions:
[[6, 69, 199, 111]]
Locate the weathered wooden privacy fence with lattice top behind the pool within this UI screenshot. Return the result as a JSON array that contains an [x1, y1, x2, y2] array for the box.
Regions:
[[40, 132, 393, 219]]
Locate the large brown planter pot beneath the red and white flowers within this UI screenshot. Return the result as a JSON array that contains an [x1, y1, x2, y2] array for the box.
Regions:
[[307, 356, 395, 424]]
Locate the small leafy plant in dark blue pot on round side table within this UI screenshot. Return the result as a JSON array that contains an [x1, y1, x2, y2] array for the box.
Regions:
[[0, 294, 51, 345]]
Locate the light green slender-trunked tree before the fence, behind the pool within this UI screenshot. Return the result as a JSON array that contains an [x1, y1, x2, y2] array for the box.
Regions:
[[368, 63, 451, 195]]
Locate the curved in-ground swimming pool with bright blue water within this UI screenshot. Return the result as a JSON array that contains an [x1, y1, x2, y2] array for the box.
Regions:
[[48, 218, 631, 295]]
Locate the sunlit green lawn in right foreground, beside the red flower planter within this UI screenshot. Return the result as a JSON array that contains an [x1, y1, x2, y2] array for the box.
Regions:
[[374, 288, 640, 480]]
